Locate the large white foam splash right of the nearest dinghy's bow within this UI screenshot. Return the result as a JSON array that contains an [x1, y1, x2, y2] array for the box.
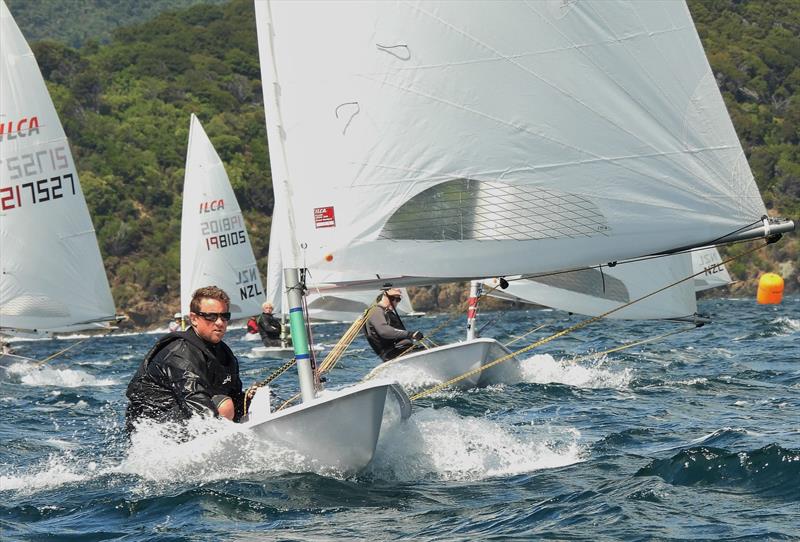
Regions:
[[368, 408, 583, 481]]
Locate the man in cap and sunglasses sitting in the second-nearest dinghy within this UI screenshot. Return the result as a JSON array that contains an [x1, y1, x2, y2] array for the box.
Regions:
[[364, 288, 423, 361]]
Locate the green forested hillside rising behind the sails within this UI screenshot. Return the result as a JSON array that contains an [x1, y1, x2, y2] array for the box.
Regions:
[[9, 0, 800, 325]]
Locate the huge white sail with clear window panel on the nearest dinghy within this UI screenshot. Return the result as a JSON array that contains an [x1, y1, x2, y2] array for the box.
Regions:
[[256, 0, 776, 285]]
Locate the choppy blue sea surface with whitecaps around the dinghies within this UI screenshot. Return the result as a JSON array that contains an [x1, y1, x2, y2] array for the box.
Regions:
[[0, 298, 800, 542]]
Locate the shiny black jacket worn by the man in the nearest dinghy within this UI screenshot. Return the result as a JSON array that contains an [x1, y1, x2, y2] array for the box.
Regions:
[[125, 328, 244, 432]]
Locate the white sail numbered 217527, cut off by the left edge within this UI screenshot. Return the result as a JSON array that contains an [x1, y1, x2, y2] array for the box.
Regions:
[[0, 0, 115, 331]]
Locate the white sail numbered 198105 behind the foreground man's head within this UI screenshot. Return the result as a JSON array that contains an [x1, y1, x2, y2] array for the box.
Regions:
[[181, 115, 264, 319]]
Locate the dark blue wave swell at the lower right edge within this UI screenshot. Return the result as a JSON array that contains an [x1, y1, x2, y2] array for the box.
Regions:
[[636, 444, 800, 499]]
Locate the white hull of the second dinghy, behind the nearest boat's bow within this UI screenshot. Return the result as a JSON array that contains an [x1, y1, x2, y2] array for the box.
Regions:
[[367, 338, 520, 390]]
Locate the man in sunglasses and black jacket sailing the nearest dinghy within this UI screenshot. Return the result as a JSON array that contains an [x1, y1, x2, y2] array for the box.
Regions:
[[125, 286, 244, 432]]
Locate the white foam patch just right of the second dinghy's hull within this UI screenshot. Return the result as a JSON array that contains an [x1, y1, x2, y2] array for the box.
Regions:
[[520, 354, 633, 389]]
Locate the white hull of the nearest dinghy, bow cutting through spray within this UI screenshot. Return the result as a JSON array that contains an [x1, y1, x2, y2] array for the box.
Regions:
[[247, 381, 410, 476]]
